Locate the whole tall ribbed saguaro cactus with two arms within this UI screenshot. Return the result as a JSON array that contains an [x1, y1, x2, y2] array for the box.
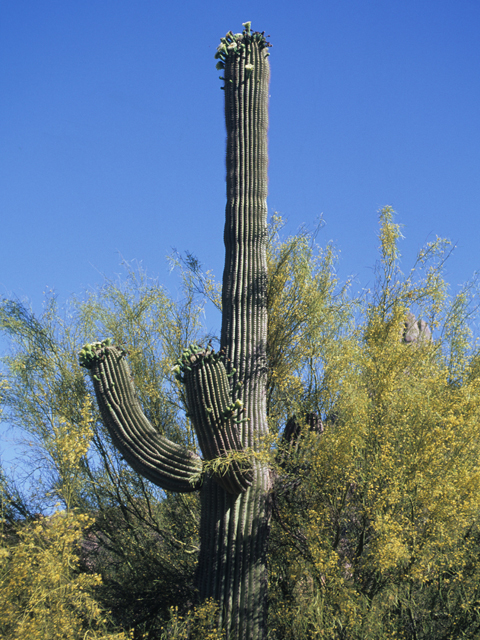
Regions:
[[80, 23, 270, 640]]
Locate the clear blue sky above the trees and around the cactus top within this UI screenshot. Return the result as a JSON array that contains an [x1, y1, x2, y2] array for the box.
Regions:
[[0, 0, 480, 322]]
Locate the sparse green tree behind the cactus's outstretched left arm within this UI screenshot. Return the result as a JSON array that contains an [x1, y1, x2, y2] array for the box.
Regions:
[[0, 269, 204, 637]]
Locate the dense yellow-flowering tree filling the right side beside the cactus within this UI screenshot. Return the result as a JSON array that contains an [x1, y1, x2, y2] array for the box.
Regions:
[[270, 208, 480, 640]]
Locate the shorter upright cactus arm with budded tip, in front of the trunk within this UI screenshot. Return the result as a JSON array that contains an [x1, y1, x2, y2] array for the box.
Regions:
[[174, 344, 253, 495]]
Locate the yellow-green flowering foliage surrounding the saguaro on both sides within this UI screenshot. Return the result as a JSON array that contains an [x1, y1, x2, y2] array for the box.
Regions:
[[0, 208, 480, 640]]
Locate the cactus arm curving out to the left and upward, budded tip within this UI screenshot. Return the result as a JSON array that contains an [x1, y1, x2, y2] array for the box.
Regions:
[[79, 340, 202, 493]]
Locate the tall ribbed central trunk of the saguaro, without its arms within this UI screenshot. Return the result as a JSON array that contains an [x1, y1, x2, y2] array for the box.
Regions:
[[198, 26, 270, 640]]
